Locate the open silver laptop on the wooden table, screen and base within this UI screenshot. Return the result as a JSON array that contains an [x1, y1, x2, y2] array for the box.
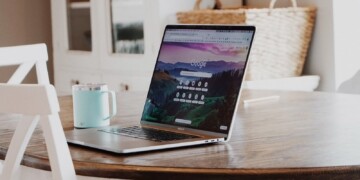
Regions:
[[65, 25, 255, 154]]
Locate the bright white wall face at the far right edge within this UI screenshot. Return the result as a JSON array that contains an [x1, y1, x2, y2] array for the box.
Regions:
[[333, 0, 360, 89]]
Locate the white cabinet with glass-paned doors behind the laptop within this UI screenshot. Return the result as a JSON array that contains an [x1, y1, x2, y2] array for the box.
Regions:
[[51, 0, 195, 95]]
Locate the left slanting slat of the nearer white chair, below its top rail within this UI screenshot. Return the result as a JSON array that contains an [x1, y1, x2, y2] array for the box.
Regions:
[[0, 116, 40, 179]]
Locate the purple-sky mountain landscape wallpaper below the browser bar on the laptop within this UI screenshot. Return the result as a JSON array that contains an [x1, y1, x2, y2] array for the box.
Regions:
[[142, 43, 247, 133]]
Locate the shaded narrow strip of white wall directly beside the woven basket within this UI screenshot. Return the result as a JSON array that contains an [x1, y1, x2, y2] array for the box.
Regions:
[[299, 0, 335, 92]]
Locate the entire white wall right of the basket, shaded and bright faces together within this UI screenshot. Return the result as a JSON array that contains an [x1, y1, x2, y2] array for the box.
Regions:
[[247, 0, 360, 92]]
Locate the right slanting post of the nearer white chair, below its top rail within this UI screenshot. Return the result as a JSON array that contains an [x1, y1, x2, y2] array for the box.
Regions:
[[40, 114, 76, 180]]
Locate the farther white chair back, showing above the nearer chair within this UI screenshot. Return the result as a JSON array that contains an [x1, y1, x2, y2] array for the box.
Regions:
[[0, 44, 50, 84]]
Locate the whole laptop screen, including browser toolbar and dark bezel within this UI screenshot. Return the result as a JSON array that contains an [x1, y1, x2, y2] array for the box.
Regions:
[[141, 25, 255, 134]]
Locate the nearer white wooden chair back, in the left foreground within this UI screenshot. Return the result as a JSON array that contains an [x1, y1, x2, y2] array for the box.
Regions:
[[0, 84, 76, 179]]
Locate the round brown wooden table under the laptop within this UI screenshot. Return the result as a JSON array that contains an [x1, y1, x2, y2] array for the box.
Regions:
[[0, 91, 360, 179]]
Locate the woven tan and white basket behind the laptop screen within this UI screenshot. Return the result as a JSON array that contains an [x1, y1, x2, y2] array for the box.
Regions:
[[177, 0, 316, 80]]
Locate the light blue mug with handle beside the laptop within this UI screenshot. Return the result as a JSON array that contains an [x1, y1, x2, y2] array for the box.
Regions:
[[72, 83, 116, 128]]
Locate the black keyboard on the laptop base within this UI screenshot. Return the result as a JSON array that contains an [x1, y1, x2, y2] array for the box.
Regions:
[[99, 126, 199, 142]]
